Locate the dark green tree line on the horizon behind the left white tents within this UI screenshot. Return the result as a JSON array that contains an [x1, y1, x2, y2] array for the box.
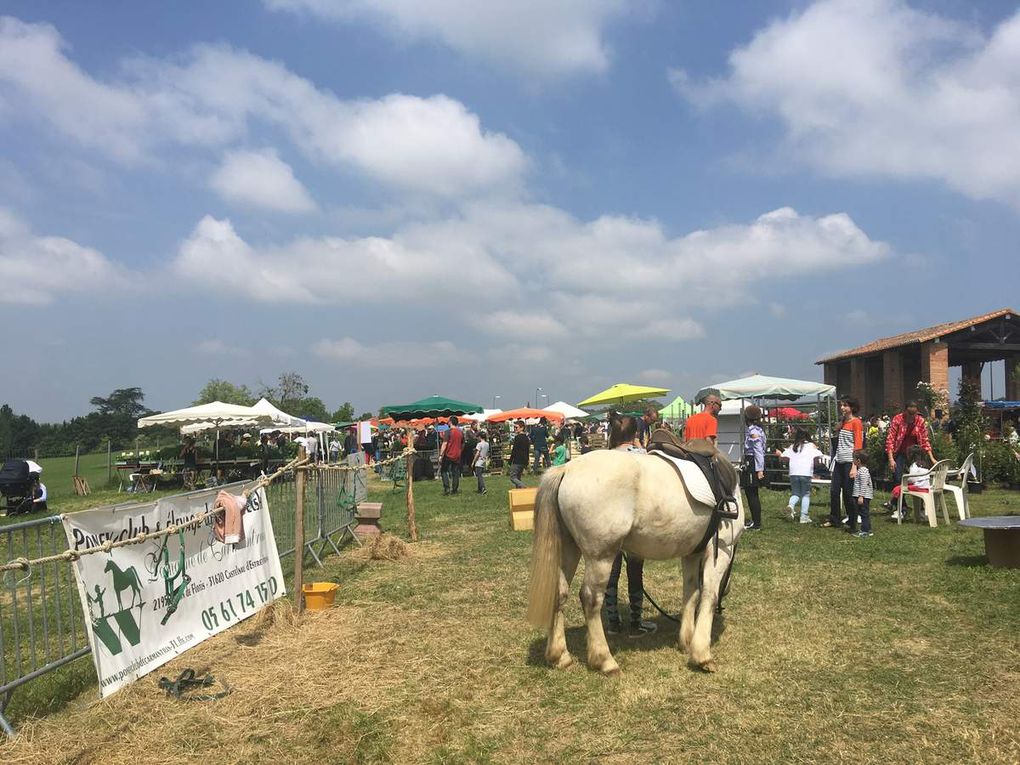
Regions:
[[0, 371, 373, 457]]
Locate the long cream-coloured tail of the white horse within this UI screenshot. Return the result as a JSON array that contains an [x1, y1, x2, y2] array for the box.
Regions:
[[527, 467, 566, 629]]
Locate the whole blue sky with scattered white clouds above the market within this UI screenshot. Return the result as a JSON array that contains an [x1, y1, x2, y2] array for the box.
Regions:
[[0, 0, 1020, 420]]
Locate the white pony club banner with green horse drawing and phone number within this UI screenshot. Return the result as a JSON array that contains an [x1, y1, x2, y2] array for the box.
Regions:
[[63, 488, 285, 697]]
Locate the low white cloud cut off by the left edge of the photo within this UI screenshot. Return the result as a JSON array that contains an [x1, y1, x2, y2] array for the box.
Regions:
[[0, 207, 123, 305]]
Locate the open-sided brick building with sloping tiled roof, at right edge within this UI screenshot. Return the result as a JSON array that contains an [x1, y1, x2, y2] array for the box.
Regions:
[[815, 308, 1020, 413]]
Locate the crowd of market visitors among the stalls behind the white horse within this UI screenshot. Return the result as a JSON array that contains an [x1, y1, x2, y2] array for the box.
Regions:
[[324, 395, 979, 538]]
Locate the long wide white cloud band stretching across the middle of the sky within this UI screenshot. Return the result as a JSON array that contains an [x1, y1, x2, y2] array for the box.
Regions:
[[165, 203, 890, 355]]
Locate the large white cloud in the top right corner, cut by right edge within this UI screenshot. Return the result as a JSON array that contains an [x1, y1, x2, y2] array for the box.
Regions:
[[671, 0, 1020, 207]]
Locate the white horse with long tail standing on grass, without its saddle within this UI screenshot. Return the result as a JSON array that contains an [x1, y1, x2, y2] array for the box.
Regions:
[[527, 450, 744, 675]]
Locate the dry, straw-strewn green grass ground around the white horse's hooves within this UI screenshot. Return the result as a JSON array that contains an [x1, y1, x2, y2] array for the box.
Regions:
[[0, 477, 1020, 765]]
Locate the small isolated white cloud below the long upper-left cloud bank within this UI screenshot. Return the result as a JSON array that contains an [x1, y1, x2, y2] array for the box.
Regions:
[[209, 149, 315, 213]]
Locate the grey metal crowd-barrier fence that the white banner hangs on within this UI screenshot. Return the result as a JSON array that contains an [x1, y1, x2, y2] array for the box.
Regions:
[[0, 470, 364, 736]]
